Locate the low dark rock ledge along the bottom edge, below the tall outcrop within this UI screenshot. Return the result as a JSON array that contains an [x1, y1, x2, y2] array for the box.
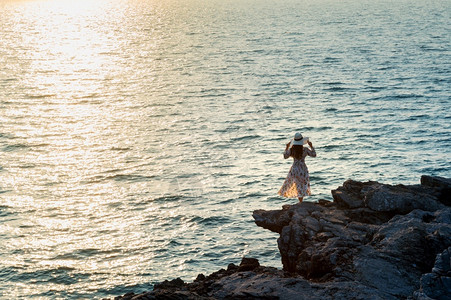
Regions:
[[114, 255, 408, 300]]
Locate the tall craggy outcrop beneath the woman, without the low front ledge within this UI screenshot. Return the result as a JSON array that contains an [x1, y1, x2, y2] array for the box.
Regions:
[[253, 178, 451, 299]]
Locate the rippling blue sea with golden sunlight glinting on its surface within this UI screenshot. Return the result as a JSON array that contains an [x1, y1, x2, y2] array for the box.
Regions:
[[0, 0, 451, 299]]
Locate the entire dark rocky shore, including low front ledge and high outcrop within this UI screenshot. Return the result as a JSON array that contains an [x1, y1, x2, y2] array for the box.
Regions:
[[115, 176, 451, 300]]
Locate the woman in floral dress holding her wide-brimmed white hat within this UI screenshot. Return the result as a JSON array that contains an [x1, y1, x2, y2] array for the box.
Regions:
[[279, 132, 316, 202]]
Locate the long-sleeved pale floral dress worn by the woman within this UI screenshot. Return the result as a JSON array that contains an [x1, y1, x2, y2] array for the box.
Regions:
[[279, 147, 316, 198]]
